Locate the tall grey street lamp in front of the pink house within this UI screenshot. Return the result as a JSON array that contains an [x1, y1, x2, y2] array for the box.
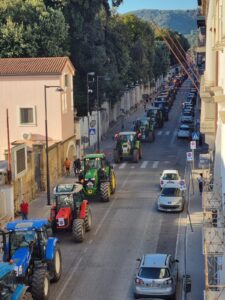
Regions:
[[44, 85, 64, 205]]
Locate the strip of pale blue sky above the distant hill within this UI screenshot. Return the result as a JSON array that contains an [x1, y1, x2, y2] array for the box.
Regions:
[[118, 0, 197, 14]]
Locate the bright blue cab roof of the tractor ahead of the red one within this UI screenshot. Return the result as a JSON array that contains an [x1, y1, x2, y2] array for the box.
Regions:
[[6, 219, 49, 231]]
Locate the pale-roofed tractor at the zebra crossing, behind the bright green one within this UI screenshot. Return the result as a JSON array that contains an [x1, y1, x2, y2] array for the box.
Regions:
[[113, 131, 142, 163]]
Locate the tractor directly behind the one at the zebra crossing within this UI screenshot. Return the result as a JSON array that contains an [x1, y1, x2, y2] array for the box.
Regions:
[[134, 117, 155, 143]]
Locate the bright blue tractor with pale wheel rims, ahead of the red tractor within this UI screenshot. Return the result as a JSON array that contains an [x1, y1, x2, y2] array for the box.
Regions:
[[1, 220, 62, 300]]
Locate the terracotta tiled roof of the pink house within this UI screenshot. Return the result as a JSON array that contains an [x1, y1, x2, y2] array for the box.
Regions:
[[0, 56, 74, 76]]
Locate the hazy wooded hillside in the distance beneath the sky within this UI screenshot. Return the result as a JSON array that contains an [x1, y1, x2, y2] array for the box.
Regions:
[[130, 9, 197, 35]]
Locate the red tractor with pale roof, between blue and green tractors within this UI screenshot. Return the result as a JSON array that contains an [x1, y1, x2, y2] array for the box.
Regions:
[[50, 183, 92, 242]]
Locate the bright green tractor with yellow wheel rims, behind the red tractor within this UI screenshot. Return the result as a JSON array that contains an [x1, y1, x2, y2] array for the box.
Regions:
[[79, 153, 116, 202]]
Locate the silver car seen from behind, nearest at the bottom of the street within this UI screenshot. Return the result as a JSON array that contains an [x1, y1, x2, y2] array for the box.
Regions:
[[134, 254, 179, 300]]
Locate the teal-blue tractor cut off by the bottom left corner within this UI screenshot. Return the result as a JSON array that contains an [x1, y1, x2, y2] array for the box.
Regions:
[[0, 262, 33, 300]]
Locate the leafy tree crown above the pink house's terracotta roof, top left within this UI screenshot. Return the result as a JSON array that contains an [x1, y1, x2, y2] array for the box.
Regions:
[[0, 0, 69, 57]]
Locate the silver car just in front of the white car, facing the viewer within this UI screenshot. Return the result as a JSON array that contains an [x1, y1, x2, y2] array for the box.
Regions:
[[157, 183, 185, 212]]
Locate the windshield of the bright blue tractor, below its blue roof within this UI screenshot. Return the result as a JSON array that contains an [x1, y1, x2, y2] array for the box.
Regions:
[[10, 230, 37, 255]]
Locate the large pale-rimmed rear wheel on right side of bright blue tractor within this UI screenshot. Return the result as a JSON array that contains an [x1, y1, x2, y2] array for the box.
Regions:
[[49, 243, 62, 282]]
